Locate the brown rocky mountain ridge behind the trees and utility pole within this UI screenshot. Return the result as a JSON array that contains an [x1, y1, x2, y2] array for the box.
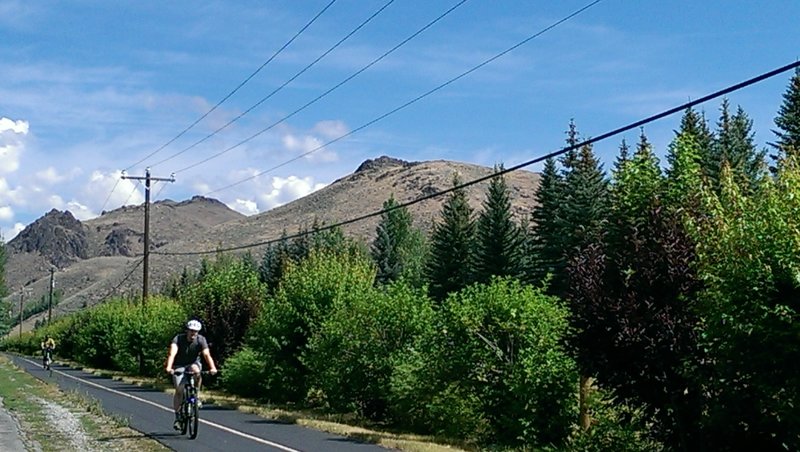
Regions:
[[6, 156, 539, 330]]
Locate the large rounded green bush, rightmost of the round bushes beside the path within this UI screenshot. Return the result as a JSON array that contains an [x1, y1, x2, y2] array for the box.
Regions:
[[391, 279, 578, 446]]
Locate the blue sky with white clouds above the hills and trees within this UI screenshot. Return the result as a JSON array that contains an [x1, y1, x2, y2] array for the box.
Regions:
[[0, 0, 800, 240]]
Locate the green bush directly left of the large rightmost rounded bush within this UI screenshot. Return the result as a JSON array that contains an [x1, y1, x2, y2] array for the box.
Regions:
[[304, 282, 433, 420]]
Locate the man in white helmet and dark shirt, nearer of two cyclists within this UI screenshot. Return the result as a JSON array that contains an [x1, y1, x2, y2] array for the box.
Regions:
[[165, 320, 217, 430]]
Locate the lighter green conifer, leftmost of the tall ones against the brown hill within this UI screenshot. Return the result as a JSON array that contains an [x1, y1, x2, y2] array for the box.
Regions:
[[370, 195, 424, 286]]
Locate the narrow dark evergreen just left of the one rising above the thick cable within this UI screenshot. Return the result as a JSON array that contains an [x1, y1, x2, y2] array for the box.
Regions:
[[524, 158, 565, 288]]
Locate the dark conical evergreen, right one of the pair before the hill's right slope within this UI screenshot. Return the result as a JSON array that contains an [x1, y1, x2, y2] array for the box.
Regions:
[[474, 165, 523, 283]]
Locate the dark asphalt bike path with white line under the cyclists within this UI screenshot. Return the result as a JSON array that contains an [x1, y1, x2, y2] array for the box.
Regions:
[[6, 354, 389, 452]]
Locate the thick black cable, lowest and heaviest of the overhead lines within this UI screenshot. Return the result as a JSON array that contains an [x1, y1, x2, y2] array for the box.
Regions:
[[153, 61, 800, 256]]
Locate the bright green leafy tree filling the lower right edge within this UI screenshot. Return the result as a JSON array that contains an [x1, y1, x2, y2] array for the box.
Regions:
[[695, 159, 800, 450]]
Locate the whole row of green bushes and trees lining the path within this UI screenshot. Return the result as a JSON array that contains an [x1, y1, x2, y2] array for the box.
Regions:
[[0, 71, 800, 450]]
